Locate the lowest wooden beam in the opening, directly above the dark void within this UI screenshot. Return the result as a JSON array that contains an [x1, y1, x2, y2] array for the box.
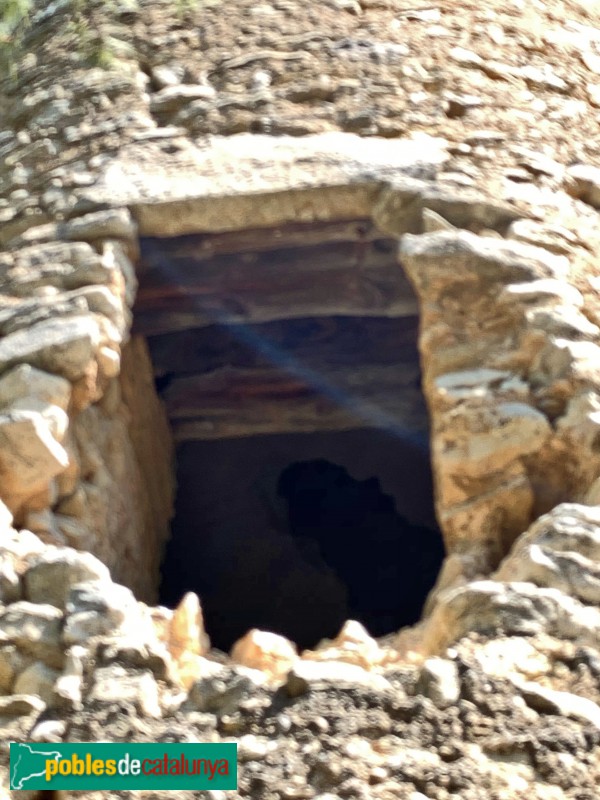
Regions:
[[164, 363, 428, 441]]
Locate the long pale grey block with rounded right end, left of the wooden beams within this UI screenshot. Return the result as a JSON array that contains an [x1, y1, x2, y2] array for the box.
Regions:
[[0, 316, 100, 381]]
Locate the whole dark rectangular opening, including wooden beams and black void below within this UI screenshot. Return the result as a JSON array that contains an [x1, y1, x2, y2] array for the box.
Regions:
[[134, 219, 443, 649]]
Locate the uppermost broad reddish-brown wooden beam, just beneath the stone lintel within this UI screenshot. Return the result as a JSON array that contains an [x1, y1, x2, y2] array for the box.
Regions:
[[134, 221, 418, 335]]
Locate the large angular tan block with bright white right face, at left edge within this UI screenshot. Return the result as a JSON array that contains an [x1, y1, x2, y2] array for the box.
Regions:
[[0, 412, 69, 508]]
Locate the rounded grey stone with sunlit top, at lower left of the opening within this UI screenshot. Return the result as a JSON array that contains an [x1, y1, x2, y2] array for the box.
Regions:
[[23, 548, 110, 609]]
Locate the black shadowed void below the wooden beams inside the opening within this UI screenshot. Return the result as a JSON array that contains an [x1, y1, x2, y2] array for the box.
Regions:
[[161, 429, 443, 650]]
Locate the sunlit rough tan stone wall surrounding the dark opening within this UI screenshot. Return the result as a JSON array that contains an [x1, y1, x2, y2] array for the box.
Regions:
[[0, 0, 600, 800]]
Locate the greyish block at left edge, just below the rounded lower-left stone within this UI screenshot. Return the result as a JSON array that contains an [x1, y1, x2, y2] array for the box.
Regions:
[[0, 600, 64, 669]]
